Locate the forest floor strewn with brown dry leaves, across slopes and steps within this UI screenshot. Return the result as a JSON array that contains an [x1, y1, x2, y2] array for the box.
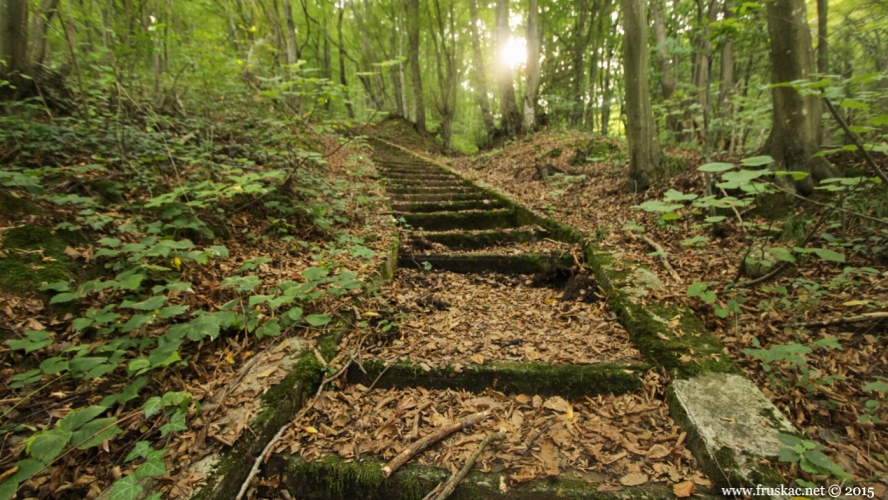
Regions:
[[0, 113, 888, 498]]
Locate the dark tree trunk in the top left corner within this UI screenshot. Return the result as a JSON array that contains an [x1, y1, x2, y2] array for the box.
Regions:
[[0, 0, 30, 95]]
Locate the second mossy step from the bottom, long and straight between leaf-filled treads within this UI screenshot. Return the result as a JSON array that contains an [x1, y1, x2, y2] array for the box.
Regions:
[[348, 361, 650, 399]]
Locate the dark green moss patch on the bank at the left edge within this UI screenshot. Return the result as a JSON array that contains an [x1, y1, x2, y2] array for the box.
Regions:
[[0, 226, 83, 293]]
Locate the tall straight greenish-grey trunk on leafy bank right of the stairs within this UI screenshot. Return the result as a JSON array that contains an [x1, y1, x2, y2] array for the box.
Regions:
[[621, 0, 660, 191]]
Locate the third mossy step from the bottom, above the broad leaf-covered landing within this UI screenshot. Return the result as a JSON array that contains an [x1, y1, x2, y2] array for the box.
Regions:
[[398, 253, 574, 274]]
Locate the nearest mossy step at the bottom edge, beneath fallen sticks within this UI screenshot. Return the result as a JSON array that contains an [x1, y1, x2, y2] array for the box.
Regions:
[[264, 454, 721, 500]]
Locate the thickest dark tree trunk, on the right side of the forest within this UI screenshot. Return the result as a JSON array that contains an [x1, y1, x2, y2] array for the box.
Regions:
[[764, 0, 833, 194]]
